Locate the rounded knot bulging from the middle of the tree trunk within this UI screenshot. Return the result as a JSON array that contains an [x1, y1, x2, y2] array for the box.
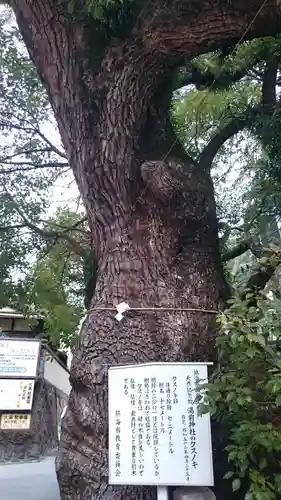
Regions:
[[141, 160, 183, 199]]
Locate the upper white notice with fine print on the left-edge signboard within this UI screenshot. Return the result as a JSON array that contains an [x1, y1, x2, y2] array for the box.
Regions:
[[0, 338, 40, 378]]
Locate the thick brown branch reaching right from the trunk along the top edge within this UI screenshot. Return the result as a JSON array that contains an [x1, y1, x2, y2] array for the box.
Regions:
[[145, 0, 281, 57]]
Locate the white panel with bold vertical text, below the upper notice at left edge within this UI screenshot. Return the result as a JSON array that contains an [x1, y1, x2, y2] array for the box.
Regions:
[[0, 378, 34, 410]]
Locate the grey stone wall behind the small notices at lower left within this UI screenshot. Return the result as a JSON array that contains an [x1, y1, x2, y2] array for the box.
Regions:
[[0, 379, 67, 462]]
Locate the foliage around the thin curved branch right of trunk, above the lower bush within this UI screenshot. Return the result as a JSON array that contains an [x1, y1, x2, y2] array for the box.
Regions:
[[173, 33, 281, 294]]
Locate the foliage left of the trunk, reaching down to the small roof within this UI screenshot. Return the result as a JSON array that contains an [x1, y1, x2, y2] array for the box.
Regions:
[[0, 10, 88, 347]]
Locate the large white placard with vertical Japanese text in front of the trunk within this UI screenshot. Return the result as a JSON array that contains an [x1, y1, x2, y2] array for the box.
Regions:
[[108, 363, 214, 486]]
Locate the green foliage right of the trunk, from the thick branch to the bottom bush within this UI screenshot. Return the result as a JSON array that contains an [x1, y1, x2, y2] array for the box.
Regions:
[[173, 38, 281, 500]]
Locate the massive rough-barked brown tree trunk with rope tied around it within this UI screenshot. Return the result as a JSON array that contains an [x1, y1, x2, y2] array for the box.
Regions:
[[8, 0, 281, 500]]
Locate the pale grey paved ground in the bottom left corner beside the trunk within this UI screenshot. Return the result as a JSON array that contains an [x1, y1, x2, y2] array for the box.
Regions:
[[0, 457, 59, 500]]
